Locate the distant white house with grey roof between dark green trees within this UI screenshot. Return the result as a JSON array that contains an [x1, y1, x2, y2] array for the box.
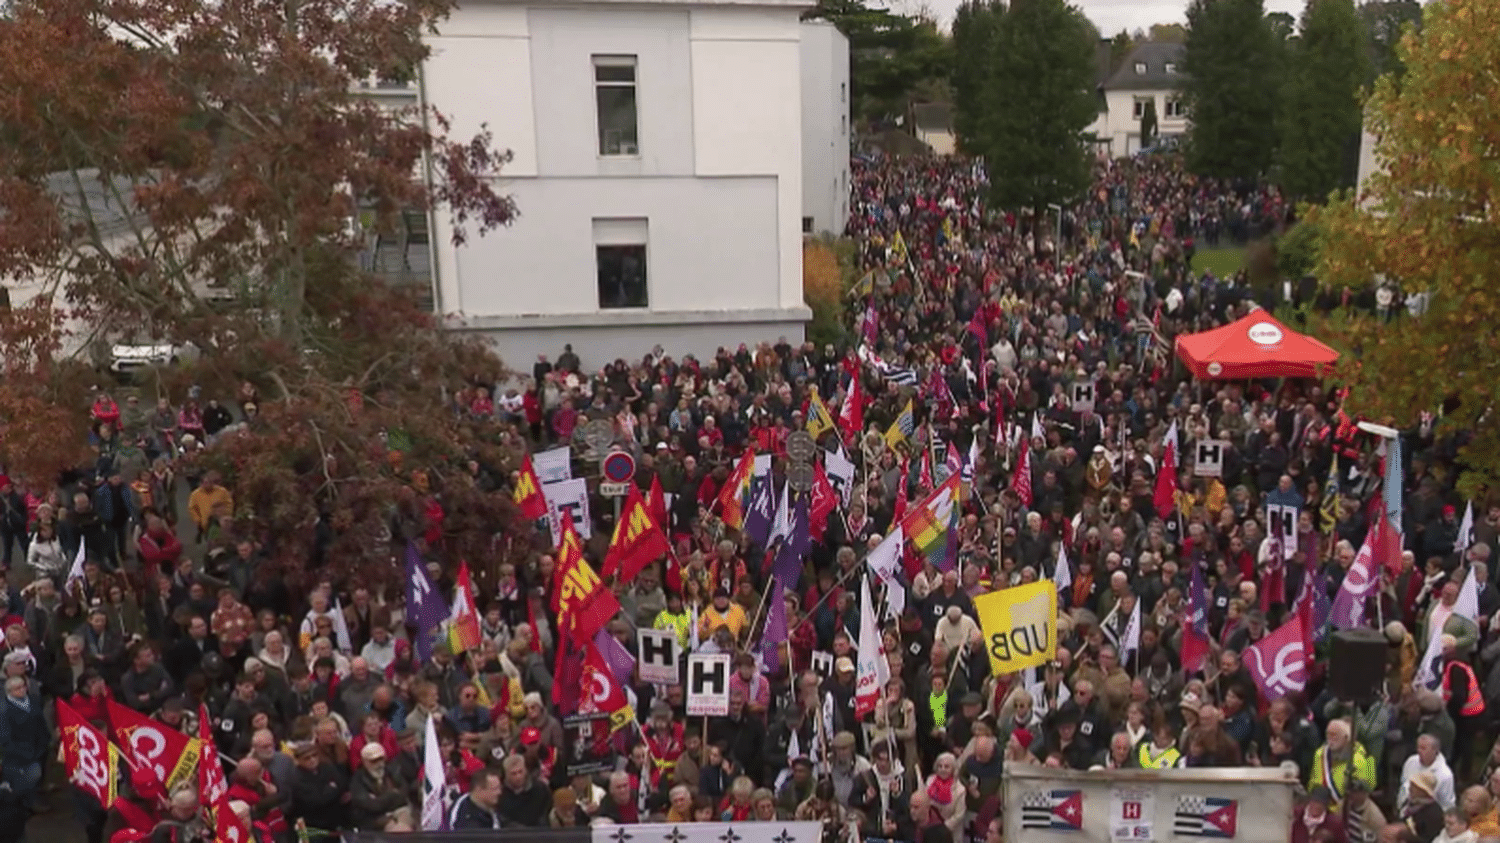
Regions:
[[1089, 41, 1188, 158]]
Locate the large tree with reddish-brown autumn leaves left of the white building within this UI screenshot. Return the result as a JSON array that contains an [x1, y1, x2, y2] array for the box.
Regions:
[[0, 0, 534, 591]]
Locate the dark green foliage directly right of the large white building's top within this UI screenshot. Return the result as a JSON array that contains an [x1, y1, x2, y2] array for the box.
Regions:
[[804, 0, 953, 120]]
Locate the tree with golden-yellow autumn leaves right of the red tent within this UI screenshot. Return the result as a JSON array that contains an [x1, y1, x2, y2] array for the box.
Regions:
[[1311, 0, 1500, 494]]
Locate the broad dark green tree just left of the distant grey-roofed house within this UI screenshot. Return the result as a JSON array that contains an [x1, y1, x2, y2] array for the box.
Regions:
[[954, 0, 1098, 210]]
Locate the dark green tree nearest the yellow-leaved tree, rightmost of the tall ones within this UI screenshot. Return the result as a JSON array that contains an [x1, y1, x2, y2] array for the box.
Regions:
[[1278, 0, 1370, 201]]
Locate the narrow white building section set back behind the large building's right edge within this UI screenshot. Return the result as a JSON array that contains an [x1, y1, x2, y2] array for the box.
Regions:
[[803, 21, 851, 234]]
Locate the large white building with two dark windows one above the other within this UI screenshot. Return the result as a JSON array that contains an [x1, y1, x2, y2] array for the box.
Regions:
[[423, 0, 812, 368]]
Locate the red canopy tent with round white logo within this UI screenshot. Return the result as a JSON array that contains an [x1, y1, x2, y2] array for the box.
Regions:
[[1176, 309, 1338, 381]]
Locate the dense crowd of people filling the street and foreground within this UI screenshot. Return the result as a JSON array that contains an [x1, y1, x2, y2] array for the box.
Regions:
[[0, 149, 1500, 843]]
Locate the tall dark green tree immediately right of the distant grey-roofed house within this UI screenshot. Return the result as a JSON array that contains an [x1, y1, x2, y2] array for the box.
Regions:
[[1182, 0, 1280, 177]]
